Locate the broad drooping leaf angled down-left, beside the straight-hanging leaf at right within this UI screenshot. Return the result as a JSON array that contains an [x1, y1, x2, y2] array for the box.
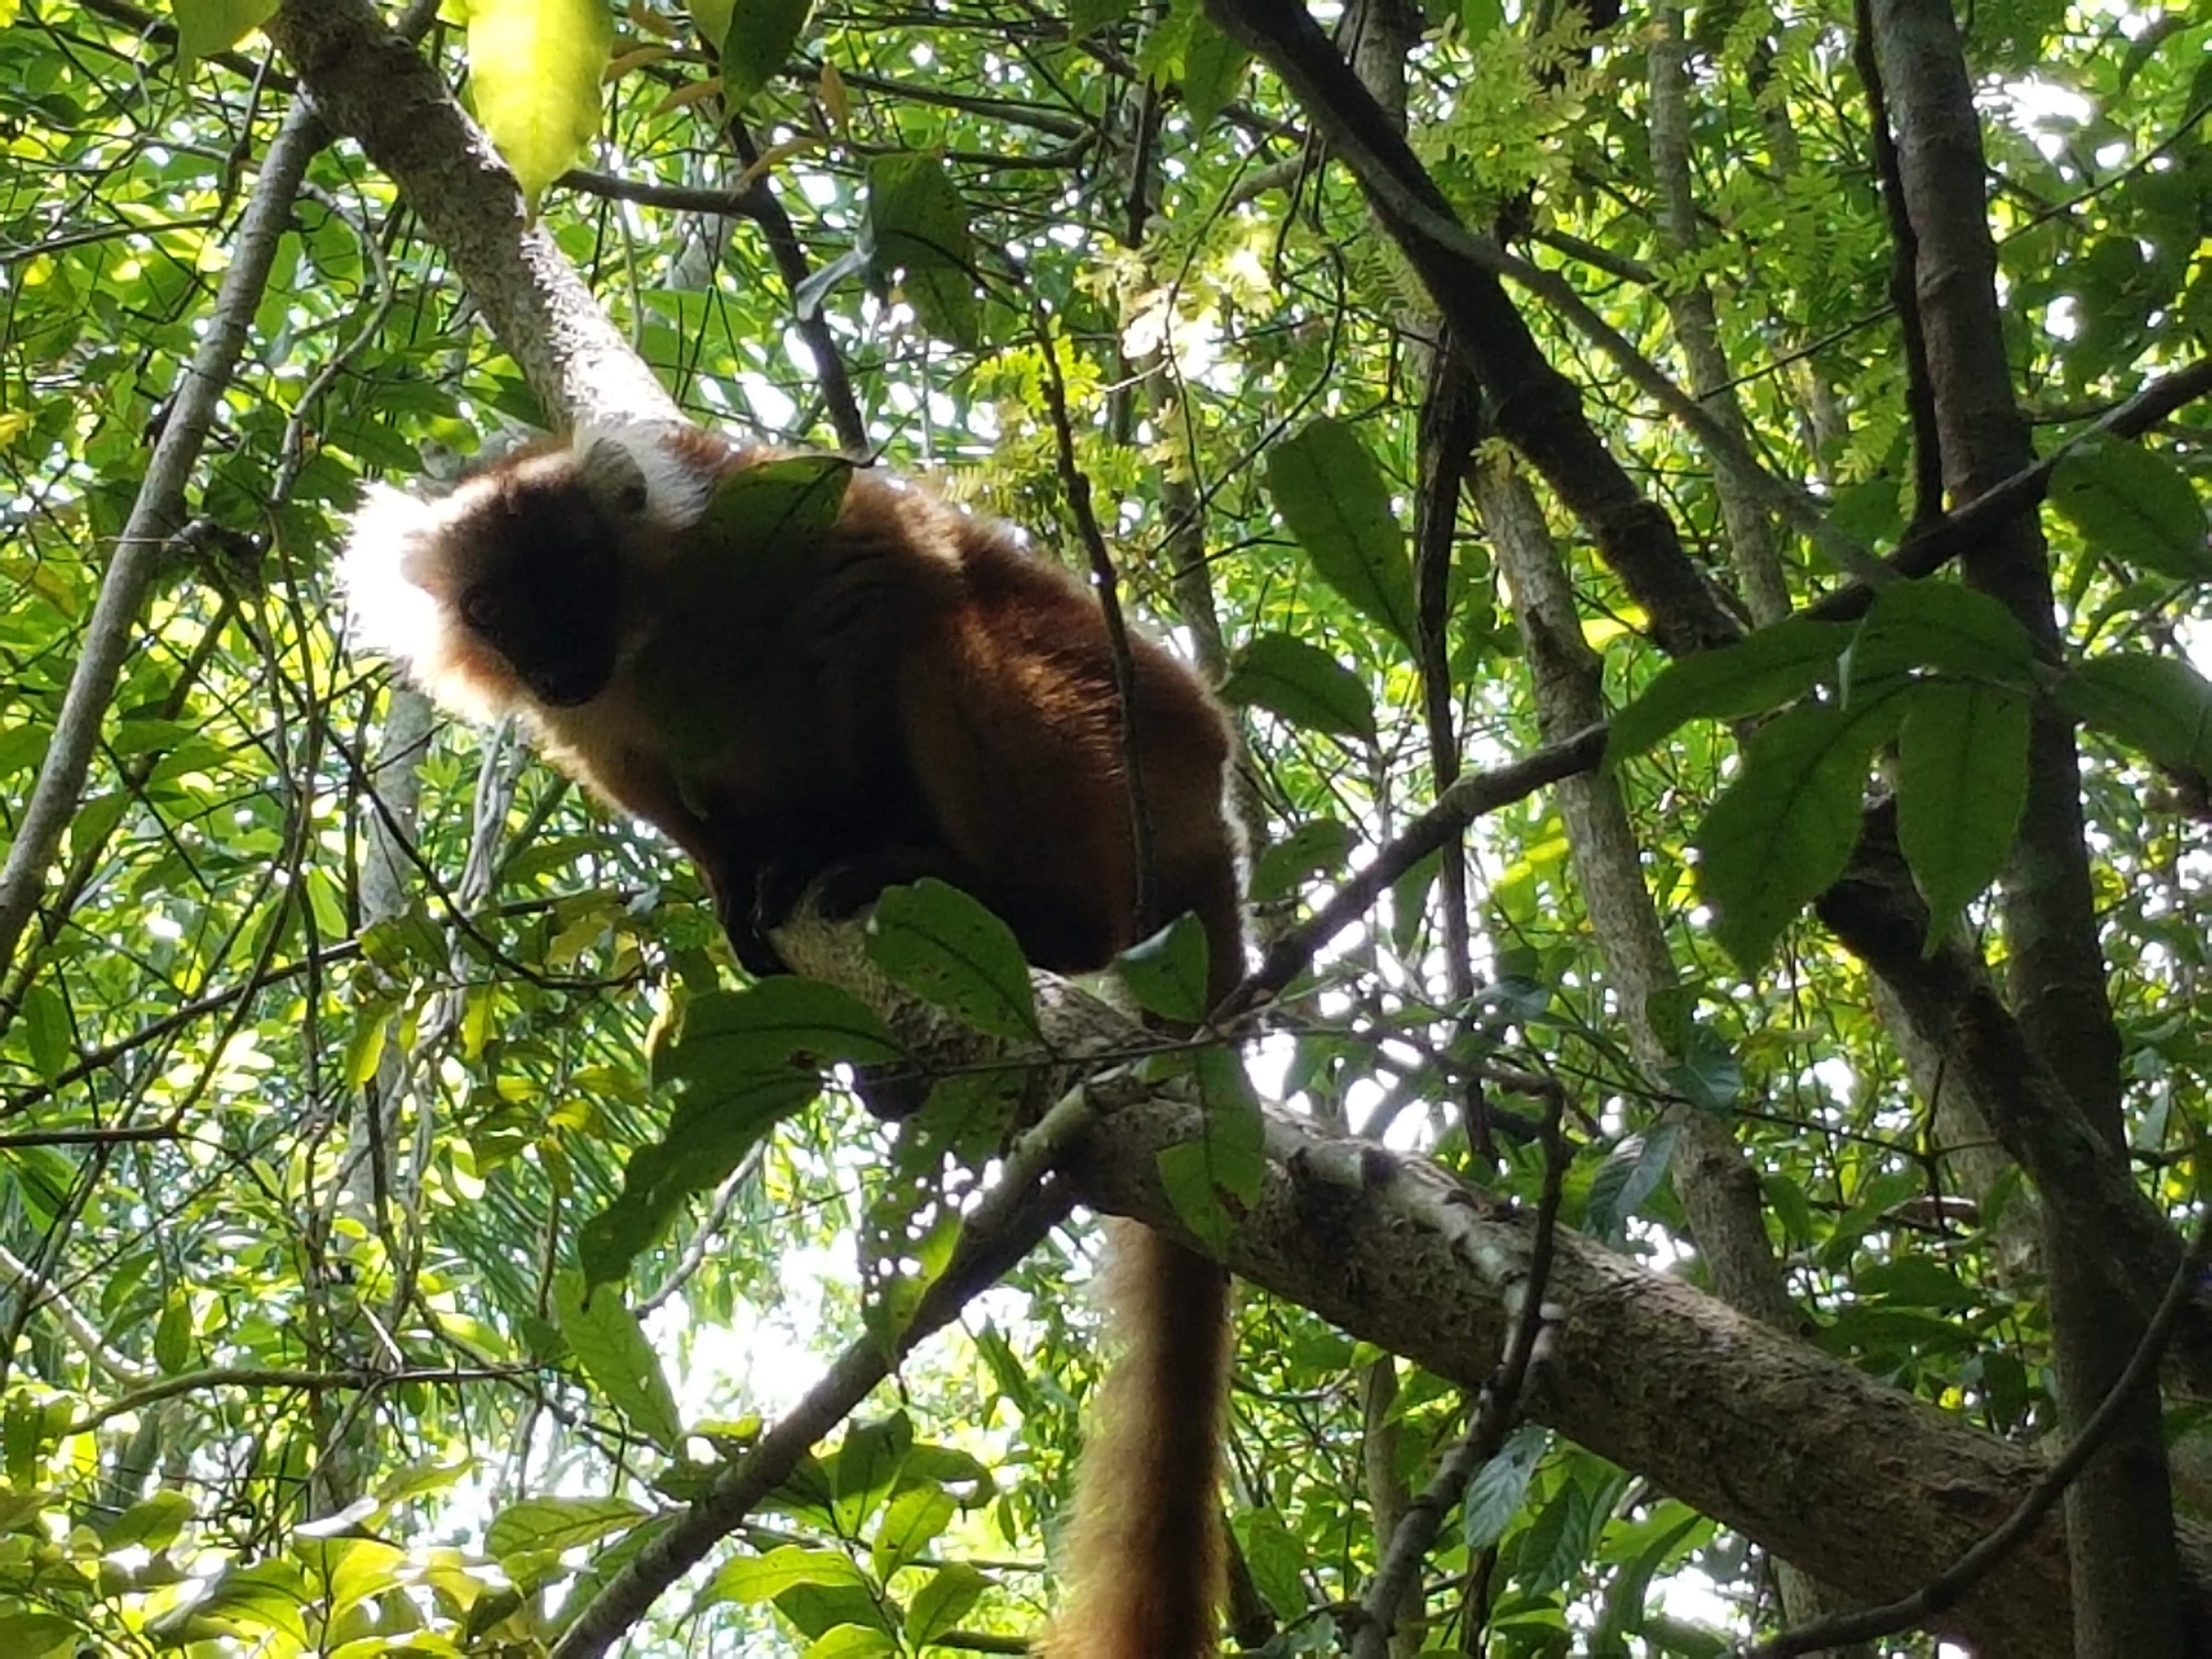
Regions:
[[1694, 695, 1900, 975]]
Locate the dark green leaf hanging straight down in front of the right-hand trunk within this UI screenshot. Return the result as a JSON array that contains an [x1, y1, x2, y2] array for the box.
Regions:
[[1896, 679, 2028, 956]]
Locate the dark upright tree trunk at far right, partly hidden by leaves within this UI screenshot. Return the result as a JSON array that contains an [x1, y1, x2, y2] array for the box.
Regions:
[[1869, 0, 2183, 1659]]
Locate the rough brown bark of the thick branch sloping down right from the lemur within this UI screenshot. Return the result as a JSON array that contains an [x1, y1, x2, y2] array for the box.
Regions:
[[1068, 1084, 2212, 1659]]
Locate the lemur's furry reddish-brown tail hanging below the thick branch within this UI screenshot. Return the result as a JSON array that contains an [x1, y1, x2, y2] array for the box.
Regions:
[[1037, 1221, 1230, 1659]]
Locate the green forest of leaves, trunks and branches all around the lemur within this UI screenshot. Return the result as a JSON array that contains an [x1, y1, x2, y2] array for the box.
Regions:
[[0, 0, 2212, 1659]]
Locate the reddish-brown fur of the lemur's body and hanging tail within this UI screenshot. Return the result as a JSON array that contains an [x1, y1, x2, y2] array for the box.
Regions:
[[347, 431, 1243, 1659]]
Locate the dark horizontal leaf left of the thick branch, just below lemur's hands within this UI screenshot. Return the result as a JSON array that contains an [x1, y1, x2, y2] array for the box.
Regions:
[[653, 973, 905, 1091]]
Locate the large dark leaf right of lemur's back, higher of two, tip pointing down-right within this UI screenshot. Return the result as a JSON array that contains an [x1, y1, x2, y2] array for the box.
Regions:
[[1267, 416, 1416, 650]]
